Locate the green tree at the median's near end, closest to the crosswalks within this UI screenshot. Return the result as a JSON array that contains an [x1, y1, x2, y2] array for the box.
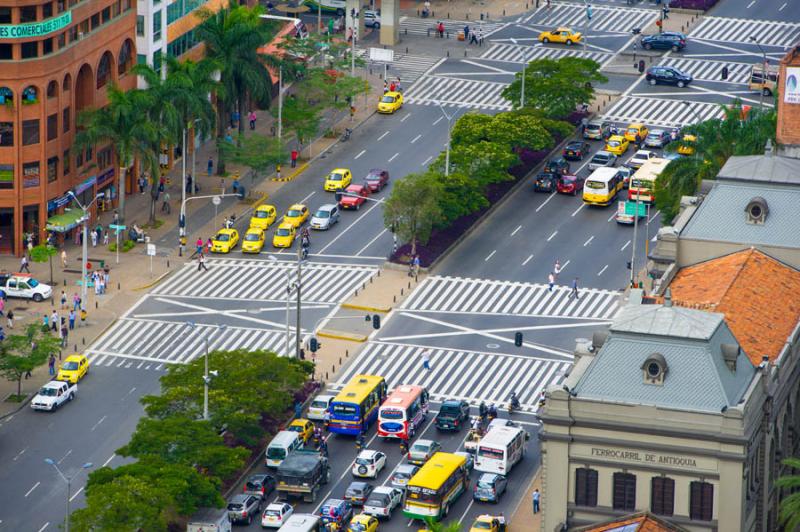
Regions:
[[383, 172, 442, 255]]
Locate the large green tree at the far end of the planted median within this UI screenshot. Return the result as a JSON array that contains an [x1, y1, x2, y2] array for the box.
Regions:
[[502, 57, 608, 118]]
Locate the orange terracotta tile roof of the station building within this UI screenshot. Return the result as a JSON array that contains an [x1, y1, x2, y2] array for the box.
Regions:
[[669, 248, 800, 365]]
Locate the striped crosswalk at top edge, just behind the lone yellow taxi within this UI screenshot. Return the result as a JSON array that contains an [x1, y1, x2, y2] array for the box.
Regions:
[[525, 3, 658, 33]]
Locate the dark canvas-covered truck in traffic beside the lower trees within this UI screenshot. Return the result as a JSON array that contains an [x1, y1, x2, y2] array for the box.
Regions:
[[276, 450, 331, 502]]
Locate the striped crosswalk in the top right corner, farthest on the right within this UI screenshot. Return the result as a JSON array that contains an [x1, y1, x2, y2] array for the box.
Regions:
[[689, 17, 800, 48]]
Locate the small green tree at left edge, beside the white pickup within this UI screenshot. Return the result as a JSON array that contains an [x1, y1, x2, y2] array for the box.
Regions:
[[0, 323, 61, 396]]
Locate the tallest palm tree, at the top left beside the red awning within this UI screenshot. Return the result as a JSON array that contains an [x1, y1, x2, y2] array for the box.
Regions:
[[197, 4, 274, 173]]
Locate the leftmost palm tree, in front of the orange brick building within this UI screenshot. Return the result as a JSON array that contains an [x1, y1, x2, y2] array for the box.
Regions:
[[75, 84, 162, 220]]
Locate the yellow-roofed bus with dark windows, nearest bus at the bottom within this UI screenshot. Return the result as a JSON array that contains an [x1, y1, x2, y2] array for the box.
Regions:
[[403, 453, 469, 521]]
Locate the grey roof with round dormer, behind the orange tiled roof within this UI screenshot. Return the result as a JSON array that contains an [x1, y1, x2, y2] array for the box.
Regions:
[[681, 181, 800, 248]]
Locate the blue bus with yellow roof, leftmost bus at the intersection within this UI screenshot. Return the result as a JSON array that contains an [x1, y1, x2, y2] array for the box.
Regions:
[[328, 375, 386, 435]]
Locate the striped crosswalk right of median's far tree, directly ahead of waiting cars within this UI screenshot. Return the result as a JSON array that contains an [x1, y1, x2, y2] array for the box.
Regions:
[[603, 96, 724, 127]]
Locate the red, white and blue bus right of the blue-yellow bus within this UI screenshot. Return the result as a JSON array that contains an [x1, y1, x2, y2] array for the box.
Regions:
[[378, 384, 428, 440]]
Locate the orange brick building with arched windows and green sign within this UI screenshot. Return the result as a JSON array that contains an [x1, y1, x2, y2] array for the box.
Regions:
[[0, 0, 136, 254]]
